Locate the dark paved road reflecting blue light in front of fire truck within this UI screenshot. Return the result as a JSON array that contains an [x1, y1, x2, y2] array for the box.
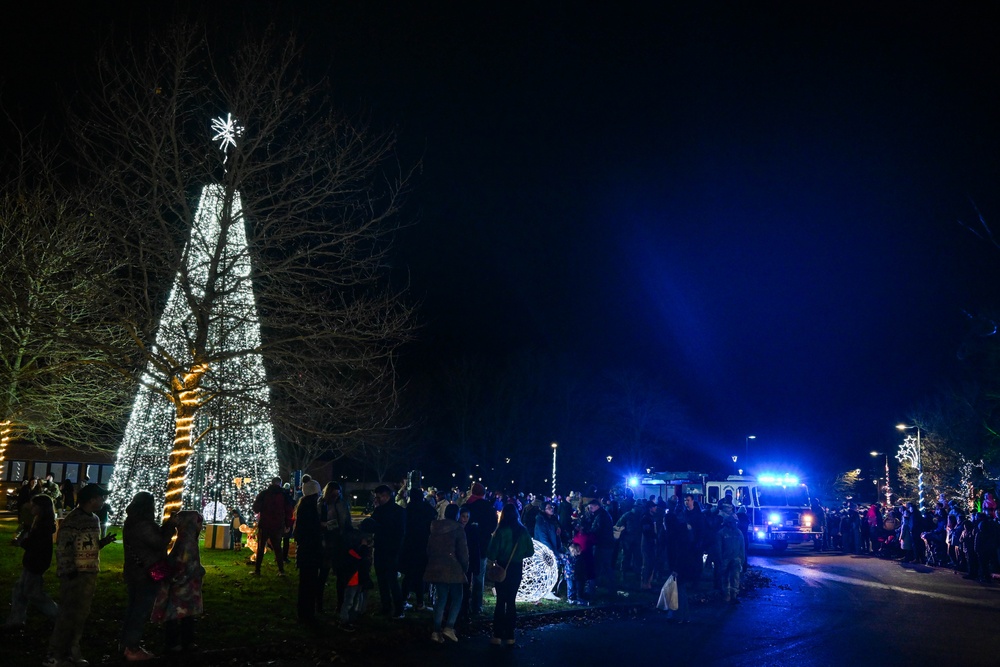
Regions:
[[248, 549, 1000, 667]]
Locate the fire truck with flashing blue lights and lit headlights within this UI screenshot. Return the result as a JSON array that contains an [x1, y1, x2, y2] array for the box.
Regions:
[[629, 470, 823, 552]]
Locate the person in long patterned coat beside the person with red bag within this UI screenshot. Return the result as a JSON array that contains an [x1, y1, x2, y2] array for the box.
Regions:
[[152, 512, 205, 653]]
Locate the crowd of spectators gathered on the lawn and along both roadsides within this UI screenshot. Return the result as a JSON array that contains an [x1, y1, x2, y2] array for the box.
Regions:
[[27, 475, 1000, 667]]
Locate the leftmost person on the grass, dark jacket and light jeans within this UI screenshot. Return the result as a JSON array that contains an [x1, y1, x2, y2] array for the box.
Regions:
[[5, 495, 59, 628]]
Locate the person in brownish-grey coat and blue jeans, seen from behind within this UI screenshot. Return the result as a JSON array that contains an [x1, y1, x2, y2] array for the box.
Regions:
[[423, 505, 469, 643]]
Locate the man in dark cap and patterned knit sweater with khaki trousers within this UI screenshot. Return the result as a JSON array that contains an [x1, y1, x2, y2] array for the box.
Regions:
[[42, 484, 117, 667]]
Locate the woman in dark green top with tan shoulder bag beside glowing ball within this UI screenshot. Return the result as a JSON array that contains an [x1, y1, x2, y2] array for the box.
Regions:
[[486, 503, 535, 647]]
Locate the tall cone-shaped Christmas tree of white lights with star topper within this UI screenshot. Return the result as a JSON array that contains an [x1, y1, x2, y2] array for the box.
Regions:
[[110, 117, 278, 522]]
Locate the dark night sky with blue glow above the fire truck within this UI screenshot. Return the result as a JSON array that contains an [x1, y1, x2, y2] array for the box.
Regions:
[[0, 1, 1000, 478]]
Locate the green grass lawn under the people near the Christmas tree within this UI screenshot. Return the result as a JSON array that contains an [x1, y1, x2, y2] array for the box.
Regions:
[[0, 514, 573, 667]]
